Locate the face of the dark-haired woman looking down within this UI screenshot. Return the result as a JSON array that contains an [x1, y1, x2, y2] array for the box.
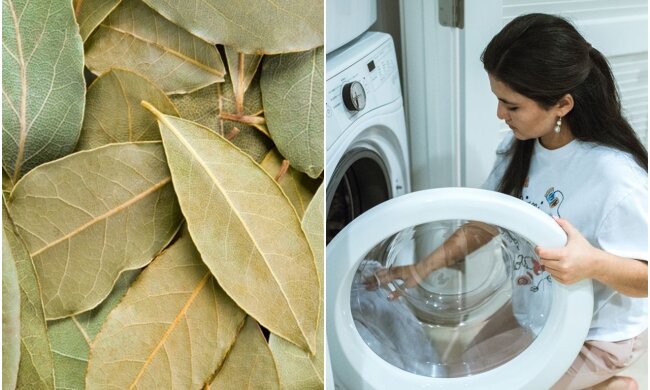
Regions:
[[488, 75, 558, 141]]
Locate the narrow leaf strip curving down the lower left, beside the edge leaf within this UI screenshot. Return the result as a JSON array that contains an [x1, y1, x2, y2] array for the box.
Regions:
[[2, 202, 54, 389]]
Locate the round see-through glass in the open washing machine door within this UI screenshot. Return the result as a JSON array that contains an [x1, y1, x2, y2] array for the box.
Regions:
[[350, 220, 552, 378]]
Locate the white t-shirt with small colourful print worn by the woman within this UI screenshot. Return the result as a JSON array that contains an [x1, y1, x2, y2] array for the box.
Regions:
[[483, 134, 648, 341]]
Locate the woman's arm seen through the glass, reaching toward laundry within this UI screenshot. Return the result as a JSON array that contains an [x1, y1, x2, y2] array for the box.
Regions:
[[364, 221, 499, 299]]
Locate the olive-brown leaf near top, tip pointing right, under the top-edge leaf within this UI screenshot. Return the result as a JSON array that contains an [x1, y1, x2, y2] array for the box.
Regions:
[[86, 0, 225, 93]]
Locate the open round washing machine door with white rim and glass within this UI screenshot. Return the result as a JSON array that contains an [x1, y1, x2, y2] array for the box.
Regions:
[[326, 188, 593, 390]]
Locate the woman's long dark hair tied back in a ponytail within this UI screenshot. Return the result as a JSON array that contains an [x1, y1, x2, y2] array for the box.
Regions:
[[481, 14, 648, 197]]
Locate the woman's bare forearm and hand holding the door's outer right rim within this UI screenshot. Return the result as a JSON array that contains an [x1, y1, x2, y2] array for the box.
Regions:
[[535, 219, 648, 297]]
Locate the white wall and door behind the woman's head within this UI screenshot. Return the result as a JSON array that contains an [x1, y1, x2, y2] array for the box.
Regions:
[[400, 0, 648, 190]]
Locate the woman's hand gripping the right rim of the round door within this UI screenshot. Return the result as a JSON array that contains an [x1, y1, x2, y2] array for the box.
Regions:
[[535, 218, 598, 284]]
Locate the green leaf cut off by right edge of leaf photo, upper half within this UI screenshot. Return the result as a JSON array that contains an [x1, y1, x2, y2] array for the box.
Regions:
[[260, 47, 324, 178]]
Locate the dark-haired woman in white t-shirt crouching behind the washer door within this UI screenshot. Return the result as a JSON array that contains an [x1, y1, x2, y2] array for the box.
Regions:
[[368, 14, 648, 389]]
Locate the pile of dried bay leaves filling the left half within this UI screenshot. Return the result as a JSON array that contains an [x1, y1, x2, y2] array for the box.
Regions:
[[2, 0, 324, 389]]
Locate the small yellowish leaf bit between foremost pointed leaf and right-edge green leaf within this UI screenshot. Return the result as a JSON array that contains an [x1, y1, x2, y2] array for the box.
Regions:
[[260, 149, 321, 218]]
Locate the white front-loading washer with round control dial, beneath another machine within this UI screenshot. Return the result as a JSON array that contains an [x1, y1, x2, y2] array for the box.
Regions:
[[325, 32, 409, 242]]
